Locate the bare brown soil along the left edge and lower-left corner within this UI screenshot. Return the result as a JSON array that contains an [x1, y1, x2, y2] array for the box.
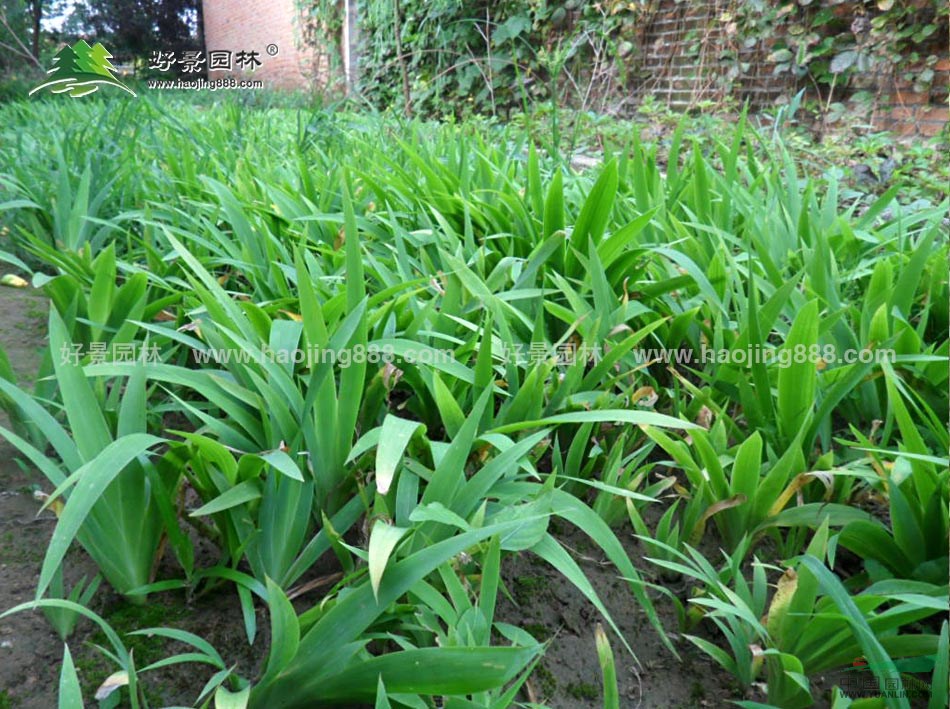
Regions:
[[0, 288, 268, 709]]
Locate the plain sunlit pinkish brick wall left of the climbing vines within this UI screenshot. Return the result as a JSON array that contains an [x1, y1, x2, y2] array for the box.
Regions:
[[203, 0, 315, 89]]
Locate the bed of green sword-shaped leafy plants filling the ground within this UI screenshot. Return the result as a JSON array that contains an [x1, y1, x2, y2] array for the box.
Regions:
[[0, 91, 950, 708]]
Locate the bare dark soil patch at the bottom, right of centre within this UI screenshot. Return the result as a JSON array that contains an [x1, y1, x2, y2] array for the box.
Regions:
[[498, 525, 742, 709]]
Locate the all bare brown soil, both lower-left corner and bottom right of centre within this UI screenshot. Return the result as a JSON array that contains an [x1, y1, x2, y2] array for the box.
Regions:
[[0, 288, 776, 709]]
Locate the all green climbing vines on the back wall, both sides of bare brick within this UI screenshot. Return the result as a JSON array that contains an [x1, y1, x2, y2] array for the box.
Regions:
[[297, 0, 950, 115]]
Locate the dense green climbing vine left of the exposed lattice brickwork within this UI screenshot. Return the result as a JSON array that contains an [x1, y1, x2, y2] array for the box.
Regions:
[[298, 0, 651, 114]]
